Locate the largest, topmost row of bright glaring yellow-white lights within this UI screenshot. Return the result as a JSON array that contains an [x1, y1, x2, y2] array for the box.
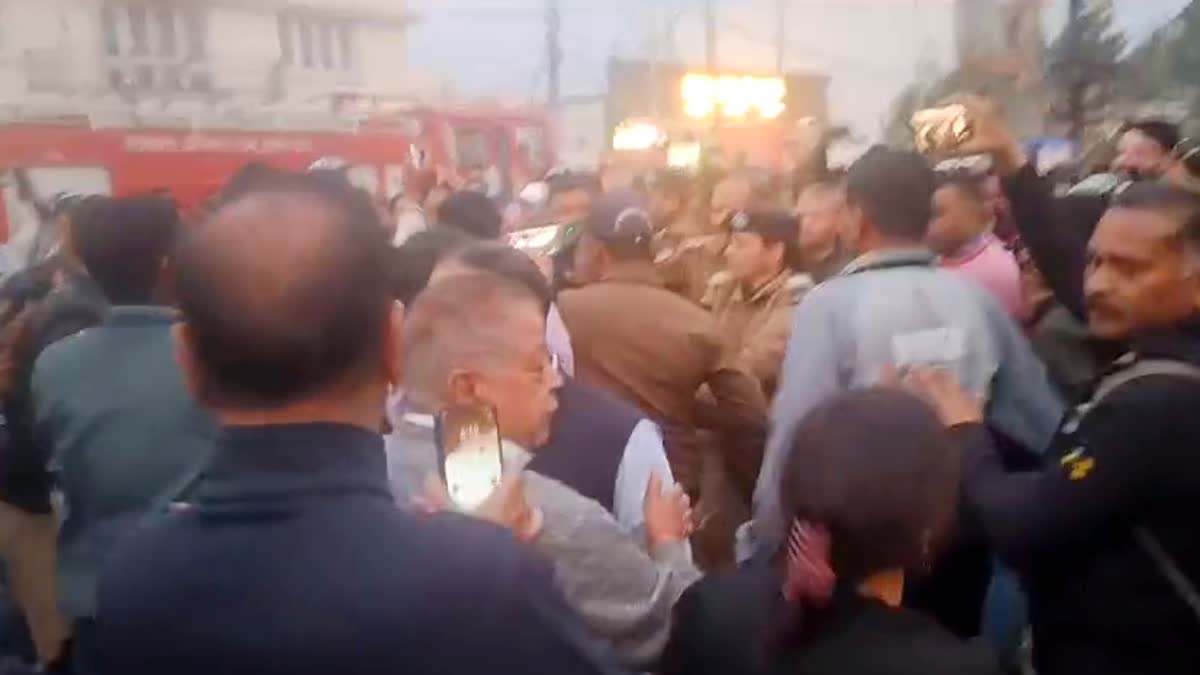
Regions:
[[680, 73, 787, 119]]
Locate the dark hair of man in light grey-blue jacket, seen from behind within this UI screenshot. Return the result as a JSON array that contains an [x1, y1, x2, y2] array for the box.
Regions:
[[846, 145, 934, 241]]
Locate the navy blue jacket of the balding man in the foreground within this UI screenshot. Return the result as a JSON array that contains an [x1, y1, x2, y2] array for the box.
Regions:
[[96, 424, 614, 675]]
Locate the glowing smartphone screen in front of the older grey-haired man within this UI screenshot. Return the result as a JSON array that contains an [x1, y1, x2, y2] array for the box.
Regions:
[[436, 406, 504, 510]]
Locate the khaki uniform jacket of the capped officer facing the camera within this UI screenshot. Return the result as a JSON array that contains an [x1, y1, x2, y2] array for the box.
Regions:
[[704, 270, 812, 400]]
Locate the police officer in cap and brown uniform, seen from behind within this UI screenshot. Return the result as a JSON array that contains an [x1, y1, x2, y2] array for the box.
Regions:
[[558, 186, 767, 569]]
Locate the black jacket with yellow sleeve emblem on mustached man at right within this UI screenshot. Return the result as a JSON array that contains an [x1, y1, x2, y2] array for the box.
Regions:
[[960, 319, 1200, 675]]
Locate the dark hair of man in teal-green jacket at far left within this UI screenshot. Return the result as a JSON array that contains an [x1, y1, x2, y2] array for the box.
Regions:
[[71, 196, 179, 300]]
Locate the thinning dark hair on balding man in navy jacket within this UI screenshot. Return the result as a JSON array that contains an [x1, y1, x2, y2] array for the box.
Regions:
[[175, 172, 392, 408]]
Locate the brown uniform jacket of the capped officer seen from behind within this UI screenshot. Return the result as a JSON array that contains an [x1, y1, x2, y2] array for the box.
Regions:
[[558, 263, 767, 494]]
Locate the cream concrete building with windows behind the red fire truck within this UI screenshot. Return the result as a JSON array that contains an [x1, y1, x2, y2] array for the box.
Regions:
[[0, 0, 440, 126]]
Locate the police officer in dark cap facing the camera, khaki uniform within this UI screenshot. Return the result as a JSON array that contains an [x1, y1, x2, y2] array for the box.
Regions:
[[706, 210, 812, 399]]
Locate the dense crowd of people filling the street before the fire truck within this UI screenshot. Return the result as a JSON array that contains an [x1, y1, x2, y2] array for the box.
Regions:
[[0, 94, 1200, 675]]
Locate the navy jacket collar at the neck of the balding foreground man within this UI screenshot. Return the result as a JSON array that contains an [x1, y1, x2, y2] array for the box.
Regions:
[[197, 423, 392, 504]]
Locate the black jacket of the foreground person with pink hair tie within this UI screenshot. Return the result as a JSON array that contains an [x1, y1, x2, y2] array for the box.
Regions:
[[662, 566, 1000, 675]]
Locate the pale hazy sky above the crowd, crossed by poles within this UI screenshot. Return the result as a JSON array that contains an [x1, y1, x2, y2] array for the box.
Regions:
[[409, 0, 1188, 136]]
